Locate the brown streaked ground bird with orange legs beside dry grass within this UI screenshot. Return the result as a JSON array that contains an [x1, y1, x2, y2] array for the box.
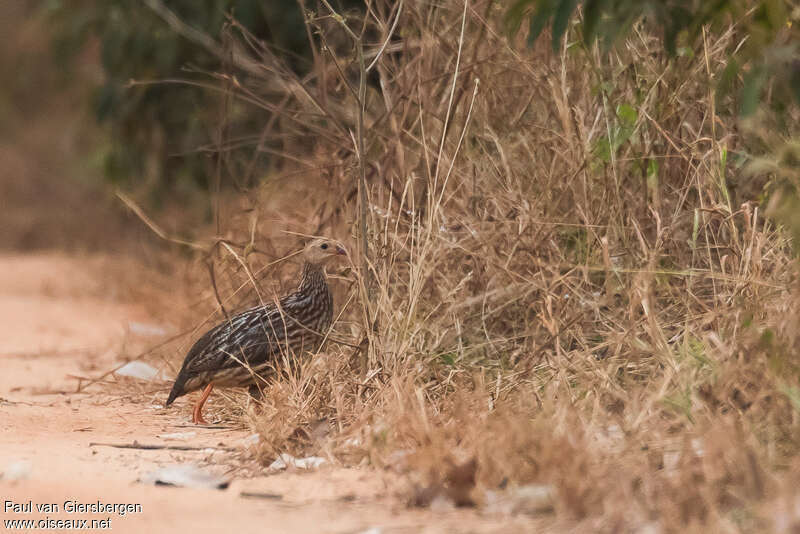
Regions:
[[166, 238, 347, 424]]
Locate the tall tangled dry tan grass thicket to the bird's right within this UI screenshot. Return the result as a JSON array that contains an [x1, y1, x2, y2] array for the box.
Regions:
[[148, 1, 800, 532]]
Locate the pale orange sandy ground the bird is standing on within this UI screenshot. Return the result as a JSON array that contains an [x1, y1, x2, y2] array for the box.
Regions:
[[0, 254, 532, 534]]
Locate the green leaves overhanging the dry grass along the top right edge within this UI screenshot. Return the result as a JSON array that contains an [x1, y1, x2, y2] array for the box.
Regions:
[[506, 0, 800, 114]]
